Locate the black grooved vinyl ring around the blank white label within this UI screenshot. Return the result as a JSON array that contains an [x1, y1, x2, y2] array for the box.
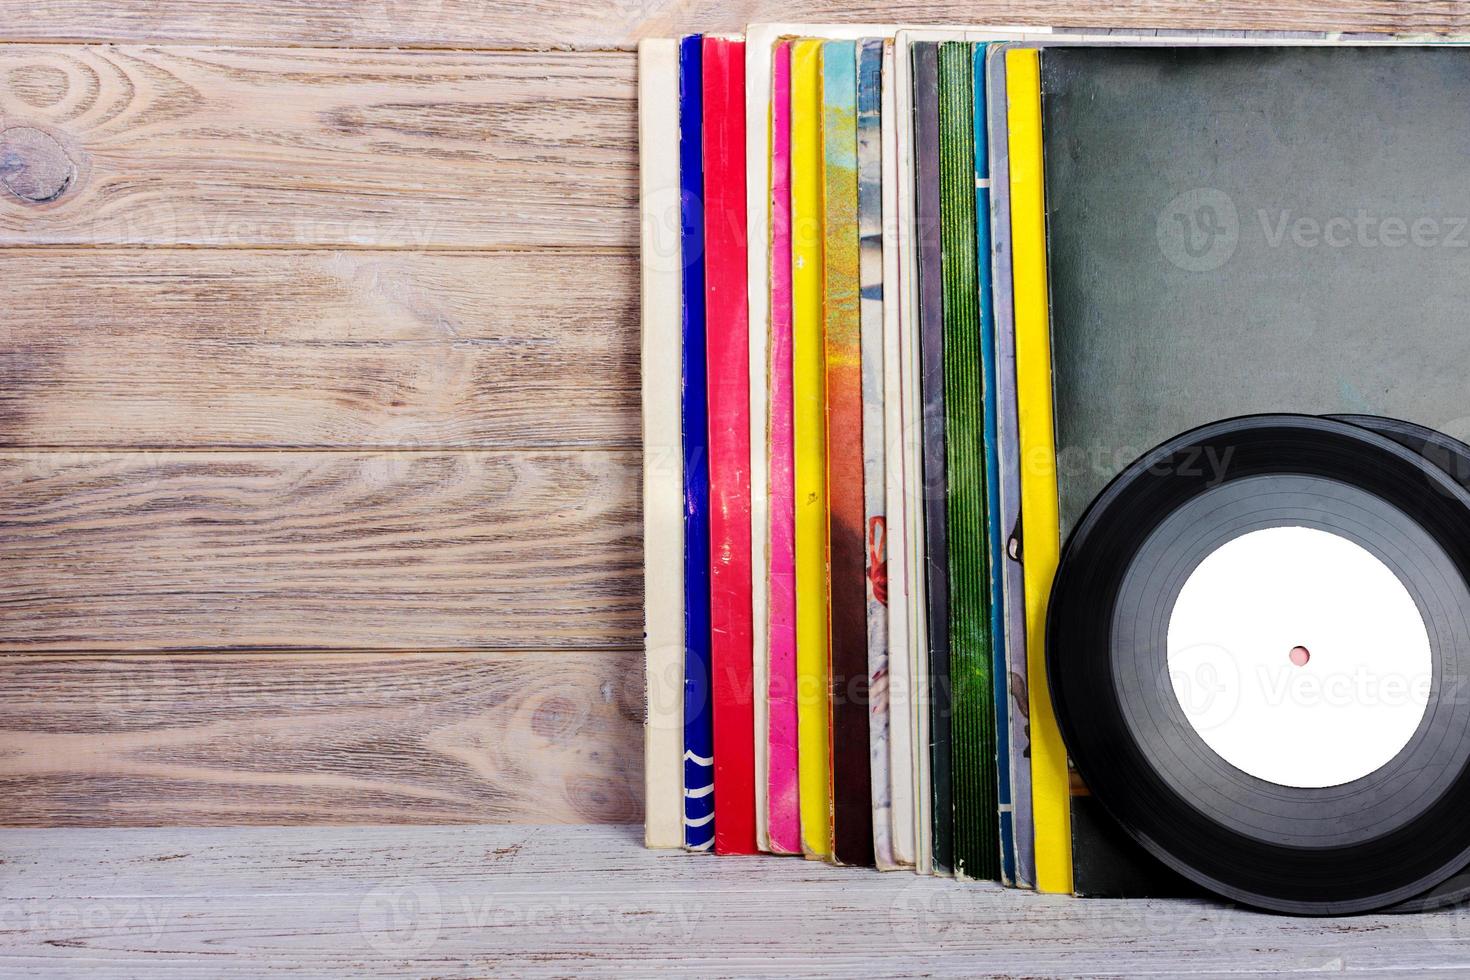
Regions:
[[1047, 414, 1470, 914]]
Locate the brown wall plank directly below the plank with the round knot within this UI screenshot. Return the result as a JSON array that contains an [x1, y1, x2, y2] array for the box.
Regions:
[[0, 250, 638, 448]]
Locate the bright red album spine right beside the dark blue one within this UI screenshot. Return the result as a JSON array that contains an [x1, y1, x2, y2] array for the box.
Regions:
[[704, 37, 757, 854]]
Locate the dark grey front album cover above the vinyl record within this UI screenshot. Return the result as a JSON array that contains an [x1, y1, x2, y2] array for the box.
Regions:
[[1041, 46, 1470, 536]]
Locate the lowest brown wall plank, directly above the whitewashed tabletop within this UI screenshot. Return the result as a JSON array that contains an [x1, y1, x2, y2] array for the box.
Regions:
[[0, 652, 642, 826]]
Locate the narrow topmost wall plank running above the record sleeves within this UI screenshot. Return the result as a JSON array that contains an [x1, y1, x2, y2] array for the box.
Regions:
[[0, 0, 1470, 50]]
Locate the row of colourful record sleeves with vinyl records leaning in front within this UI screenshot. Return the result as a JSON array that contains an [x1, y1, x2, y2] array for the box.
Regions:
[[639, 25, 1470, 914]]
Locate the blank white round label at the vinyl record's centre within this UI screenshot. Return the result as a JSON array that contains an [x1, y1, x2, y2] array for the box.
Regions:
[[1167, 527, 1433, 788]]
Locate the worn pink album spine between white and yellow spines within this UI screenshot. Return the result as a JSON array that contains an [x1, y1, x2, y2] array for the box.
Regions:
[[766, 41, 801, 854]]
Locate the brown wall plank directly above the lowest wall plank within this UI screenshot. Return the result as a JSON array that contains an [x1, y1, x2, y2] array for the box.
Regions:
[[0, 451, 642, 652]]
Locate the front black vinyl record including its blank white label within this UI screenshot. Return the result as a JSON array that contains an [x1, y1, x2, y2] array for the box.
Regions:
[[1047, 416, 1470, 914]]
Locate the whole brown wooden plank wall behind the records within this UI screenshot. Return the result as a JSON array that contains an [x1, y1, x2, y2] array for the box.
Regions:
[[0, 0, 1470, 826]]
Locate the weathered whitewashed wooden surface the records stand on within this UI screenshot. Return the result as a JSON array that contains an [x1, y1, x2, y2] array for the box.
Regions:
[[0, 827, 1470, 980]]
